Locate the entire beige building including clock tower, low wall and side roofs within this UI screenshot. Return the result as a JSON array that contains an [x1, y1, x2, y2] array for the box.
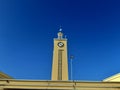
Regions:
[[0, 29, 120, 90]]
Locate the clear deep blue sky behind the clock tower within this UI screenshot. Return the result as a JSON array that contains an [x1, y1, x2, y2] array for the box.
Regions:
[[0, 0, 120, 81]]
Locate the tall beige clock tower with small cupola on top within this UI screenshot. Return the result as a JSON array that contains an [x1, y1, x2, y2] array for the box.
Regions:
[[52, 28, 68, 80]]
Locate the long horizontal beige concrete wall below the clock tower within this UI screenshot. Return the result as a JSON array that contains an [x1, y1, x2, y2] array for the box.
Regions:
[[0, 80, 120, 90]]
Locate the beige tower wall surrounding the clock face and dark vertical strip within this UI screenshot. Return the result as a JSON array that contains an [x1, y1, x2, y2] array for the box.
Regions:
[[52, 39, 68, 80]]
